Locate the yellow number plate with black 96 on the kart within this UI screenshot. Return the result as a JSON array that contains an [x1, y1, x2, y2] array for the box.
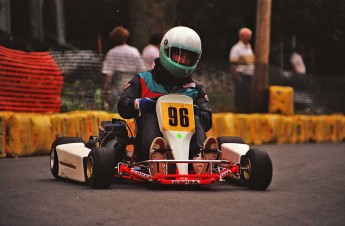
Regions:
[[161, 103, 194, 132]]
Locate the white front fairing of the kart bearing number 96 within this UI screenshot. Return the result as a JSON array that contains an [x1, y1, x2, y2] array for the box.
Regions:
[[156, 94, 195, 175]]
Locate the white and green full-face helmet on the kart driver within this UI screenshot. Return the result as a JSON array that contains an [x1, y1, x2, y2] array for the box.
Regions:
[[159, 26, 201, 78]]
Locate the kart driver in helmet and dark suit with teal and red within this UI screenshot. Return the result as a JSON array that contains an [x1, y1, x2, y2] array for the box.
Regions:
[[117, 26, 217, 173]]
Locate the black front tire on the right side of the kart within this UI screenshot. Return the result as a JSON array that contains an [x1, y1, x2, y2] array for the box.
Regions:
[[240, 149, 273, 191]]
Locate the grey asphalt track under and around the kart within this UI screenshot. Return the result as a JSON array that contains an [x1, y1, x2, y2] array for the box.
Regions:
[[0, 143, 345, 226]]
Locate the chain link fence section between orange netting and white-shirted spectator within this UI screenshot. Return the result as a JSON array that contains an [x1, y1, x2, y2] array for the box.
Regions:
[[51, 50, 104, 112]]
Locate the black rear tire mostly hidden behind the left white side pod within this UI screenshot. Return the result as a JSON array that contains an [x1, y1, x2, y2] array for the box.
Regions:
[[50, 137, 84, 179]]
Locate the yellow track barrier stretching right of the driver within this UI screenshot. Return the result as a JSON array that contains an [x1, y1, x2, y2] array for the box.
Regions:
[[207, 113, 345, 144]]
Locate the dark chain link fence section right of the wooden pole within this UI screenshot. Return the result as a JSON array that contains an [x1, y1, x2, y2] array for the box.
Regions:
[[269, 66, 345, 115]]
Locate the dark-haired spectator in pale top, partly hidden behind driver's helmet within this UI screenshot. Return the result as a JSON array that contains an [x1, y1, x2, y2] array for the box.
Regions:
[[142, 33, 162, 69]]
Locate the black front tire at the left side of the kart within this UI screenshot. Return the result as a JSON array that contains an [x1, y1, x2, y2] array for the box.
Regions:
[[85, 147, 115, 188]]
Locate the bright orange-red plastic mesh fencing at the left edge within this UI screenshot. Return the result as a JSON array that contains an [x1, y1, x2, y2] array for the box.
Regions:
[[0, 46, 63, 112]]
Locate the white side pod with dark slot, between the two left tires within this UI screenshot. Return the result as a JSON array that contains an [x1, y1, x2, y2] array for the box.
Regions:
[[56, 143, 91, 182]]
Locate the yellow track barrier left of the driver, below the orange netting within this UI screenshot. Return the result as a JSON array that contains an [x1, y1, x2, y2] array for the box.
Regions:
[[0, 111, 135, 157]]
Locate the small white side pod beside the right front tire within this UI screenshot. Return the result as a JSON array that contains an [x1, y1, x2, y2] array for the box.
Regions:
[[220, 143, 249, 163]]
